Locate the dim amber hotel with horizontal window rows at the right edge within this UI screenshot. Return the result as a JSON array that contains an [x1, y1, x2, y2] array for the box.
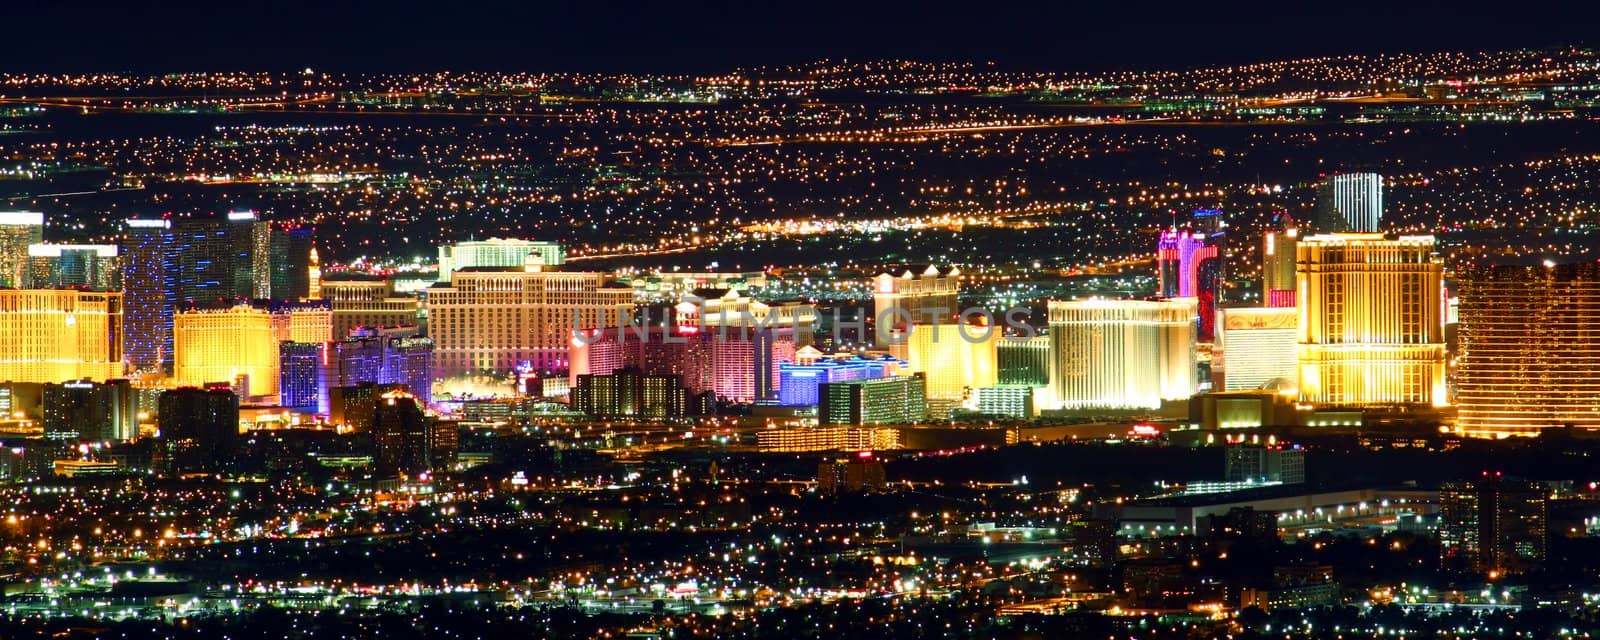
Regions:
[[1456, 262, 1600, 435]]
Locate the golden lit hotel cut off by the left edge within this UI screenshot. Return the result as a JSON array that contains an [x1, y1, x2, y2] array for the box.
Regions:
[[0, 290, 122, 382]]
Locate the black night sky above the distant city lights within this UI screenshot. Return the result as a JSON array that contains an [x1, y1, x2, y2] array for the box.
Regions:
[[0, 0, 1600, 72]]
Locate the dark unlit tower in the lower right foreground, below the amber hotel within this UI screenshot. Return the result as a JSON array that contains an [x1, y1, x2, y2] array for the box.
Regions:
[[1438, 474, 1550, 576]]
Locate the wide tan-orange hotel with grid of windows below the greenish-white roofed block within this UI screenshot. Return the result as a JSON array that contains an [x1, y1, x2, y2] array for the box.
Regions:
[[424, 264, 634, 378]]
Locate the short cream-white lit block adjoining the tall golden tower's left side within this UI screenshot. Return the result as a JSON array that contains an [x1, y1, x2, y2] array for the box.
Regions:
[[1211, 307, 1299, 390]]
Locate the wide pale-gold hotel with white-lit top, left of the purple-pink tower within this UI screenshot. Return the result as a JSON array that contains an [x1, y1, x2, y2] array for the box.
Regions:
[[1048, 298, 1198, 410]]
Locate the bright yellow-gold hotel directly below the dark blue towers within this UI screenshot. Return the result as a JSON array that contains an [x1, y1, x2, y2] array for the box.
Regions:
[[173, 301, 333, 398]]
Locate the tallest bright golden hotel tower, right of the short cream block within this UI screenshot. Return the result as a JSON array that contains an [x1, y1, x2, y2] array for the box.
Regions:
[[1296, 234, 1448, 408]]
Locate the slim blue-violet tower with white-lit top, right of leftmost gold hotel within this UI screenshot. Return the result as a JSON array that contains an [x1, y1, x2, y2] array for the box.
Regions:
[[118, 219, 176, 371]]
